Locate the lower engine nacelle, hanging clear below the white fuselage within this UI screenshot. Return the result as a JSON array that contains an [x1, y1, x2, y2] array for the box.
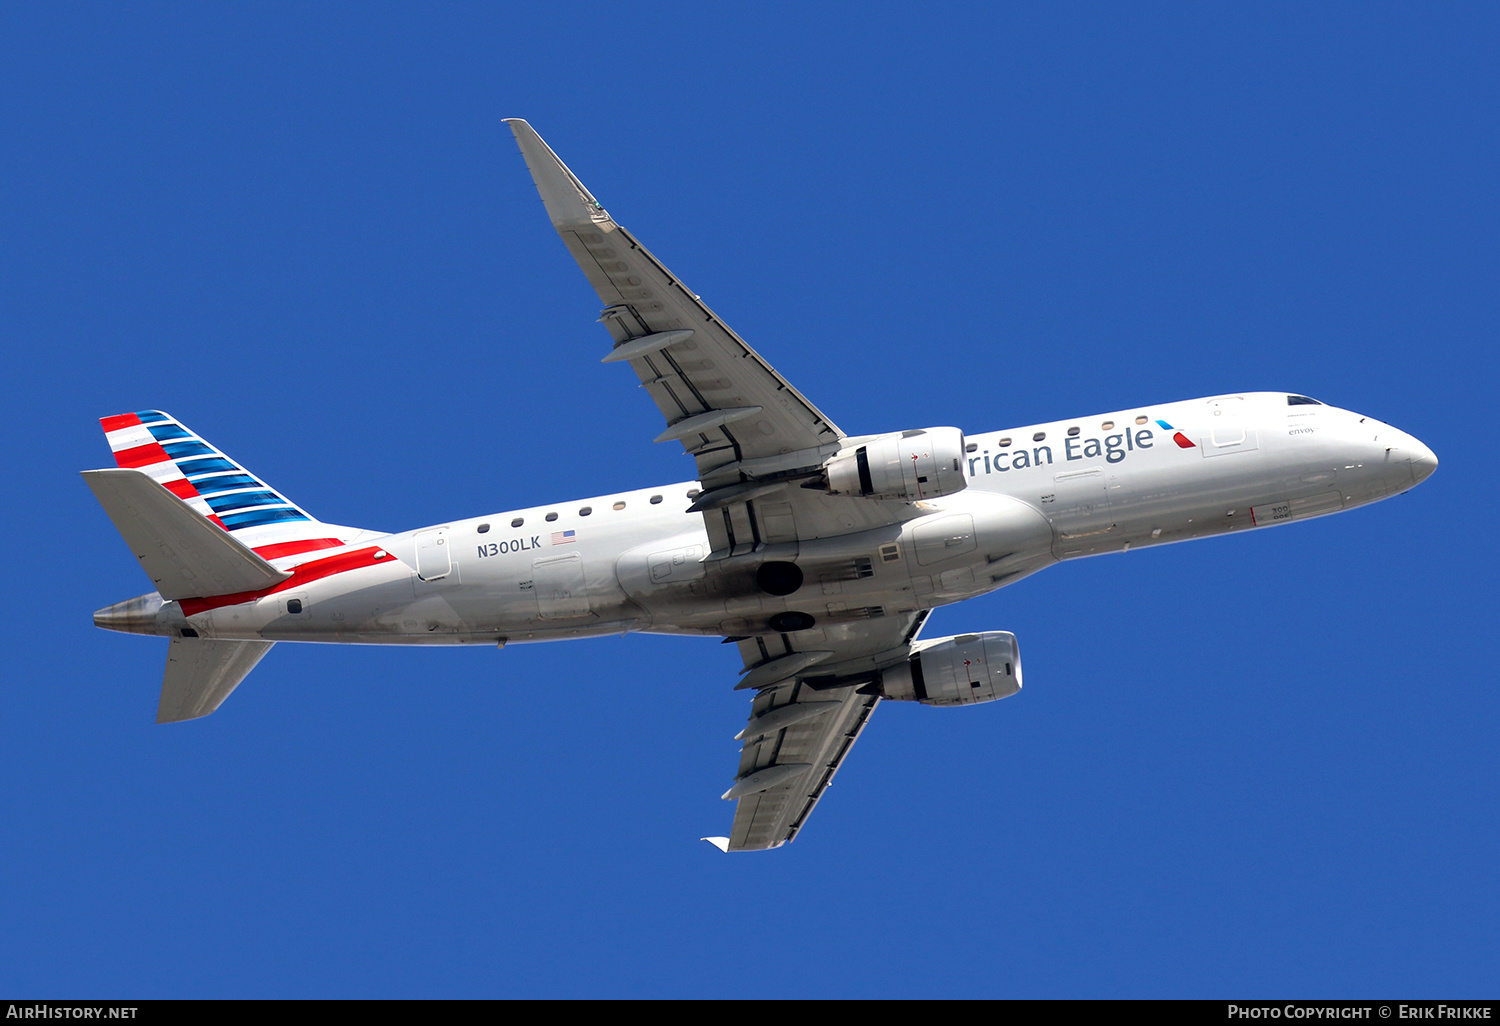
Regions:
[[881, 630, 1022, 705]]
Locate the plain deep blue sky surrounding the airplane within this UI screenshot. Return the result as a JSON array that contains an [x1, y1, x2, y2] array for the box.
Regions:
[[0, 3, 1500, 998]]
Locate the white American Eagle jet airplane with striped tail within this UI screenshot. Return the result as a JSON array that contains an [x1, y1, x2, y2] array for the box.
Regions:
[[83, 119, 1437, 852]]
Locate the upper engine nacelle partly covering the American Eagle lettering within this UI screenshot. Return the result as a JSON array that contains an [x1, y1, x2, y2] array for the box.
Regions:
[[824, 428, 969, 501]]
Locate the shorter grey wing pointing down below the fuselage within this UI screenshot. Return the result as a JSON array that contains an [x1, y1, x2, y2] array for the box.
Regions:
[[705, 612, 927, 852]]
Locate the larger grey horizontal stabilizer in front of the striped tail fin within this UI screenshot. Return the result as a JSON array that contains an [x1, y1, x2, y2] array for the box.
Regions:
[[83, 468, 291, 606]]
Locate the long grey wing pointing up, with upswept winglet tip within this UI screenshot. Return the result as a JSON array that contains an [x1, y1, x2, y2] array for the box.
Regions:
[[507, 119, 915, 558]]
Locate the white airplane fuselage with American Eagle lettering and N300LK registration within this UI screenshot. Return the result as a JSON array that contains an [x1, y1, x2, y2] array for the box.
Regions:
[[101, 393, 1437, 645]]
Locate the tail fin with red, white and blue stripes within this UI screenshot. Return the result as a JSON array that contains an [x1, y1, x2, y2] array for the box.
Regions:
[[99, 410, 357, 560]]
